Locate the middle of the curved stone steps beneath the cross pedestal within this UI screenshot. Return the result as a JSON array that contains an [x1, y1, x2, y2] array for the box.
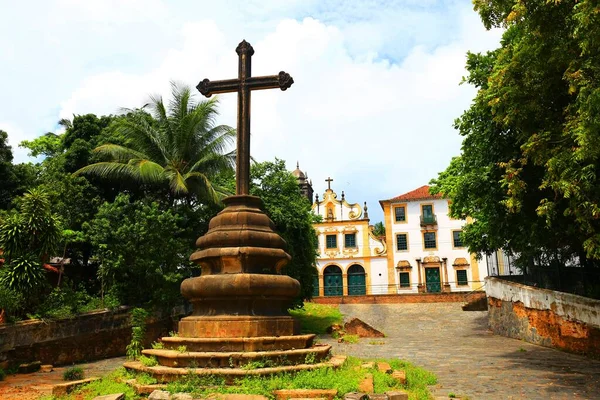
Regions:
[[142, 345, 331, 368]]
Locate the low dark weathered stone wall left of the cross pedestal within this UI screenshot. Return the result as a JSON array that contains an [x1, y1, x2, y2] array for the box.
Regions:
[[0, 307, 173, 366]]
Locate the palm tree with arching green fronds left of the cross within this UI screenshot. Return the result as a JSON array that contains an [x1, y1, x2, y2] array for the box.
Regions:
[[75, 83, 235, 203]]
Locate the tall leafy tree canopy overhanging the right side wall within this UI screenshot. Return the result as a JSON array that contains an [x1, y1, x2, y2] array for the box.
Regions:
[[432, 0, 600, 266]]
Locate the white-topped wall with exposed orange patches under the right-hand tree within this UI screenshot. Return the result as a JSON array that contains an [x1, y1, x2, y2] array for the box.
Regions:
[[486, 277, 600, 358]]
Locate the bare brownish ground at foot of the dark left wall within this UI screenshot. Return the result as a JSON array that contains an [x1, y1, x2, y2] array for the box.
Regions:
[[0, 357, 126, 400]]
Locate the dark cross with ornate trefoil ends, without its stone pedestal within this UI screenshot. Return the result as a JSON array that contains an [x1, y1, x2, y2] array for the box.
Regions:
[[196, 40, 294, 195]]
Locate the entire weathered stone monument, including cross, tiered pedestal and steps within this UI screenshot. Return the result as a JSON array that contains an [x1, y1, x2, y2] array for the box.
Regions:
[[125, 41, 331, 381]]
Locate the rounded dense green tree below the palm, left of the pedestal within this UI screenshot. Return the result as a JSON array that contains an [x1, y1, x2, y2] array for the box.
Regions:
[[84, 194, 193, 308]]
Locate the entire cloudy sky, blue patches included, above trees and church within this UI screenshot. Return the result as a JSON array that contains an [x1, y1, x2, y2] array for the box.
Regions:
[[0, 0, 501, 223]]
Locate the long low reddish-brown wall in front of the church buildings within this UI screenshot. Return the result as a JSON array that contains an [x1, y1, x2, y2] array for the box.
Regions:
[[311, 291, 485, 304]]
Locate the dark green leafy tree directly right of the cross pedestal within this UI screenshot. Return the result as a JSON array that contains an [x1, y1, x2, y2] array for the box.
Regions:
[[250, 159, 318, 305]]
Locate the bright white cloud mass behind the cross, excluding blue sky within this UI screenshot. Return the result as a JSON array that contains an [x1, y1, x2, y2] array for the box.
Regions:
[[0, 0, 500, 221]]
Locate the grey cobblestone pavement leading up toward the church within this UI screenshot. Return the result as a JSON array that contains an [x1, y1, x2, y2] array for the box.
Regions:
[[321, 303, 600, 400]]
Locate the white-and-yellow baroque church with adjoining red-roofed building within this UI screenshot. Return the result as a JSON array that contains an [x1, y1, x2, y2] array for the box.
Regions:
[[292, 164, 489, 296]]
